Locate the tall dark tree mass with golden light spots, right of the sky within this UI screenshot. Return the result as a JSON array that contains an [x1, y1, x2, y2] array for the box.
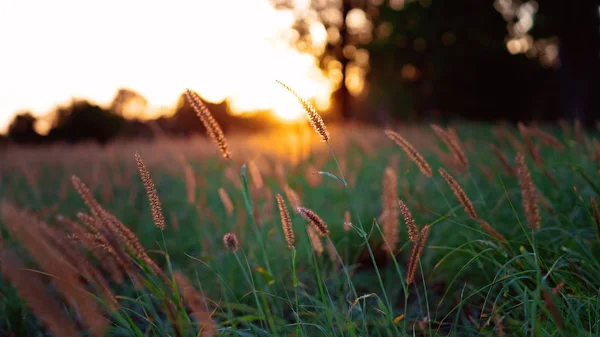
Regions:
[[280, 0, 600, 122]]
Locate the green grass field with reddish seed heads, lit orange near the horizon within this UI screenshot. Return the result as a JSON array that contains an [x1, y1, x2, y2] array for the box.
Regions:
[[0, 119, 600, 337]]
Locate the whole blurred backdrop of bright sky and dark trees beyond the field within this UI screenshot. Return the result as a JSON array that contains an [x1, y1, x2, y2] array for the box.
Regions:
[[0, 0, 600, 144]]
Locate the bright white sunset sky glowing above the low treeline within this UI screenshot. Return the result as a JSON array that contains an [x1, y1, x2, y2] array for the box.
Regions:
[[0, 0, 332, 132]]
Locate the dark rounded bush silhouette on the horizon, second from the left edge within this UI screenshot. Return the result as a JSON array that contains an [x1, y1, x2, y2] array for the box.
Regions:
[[48, 100, 126, 143]]
